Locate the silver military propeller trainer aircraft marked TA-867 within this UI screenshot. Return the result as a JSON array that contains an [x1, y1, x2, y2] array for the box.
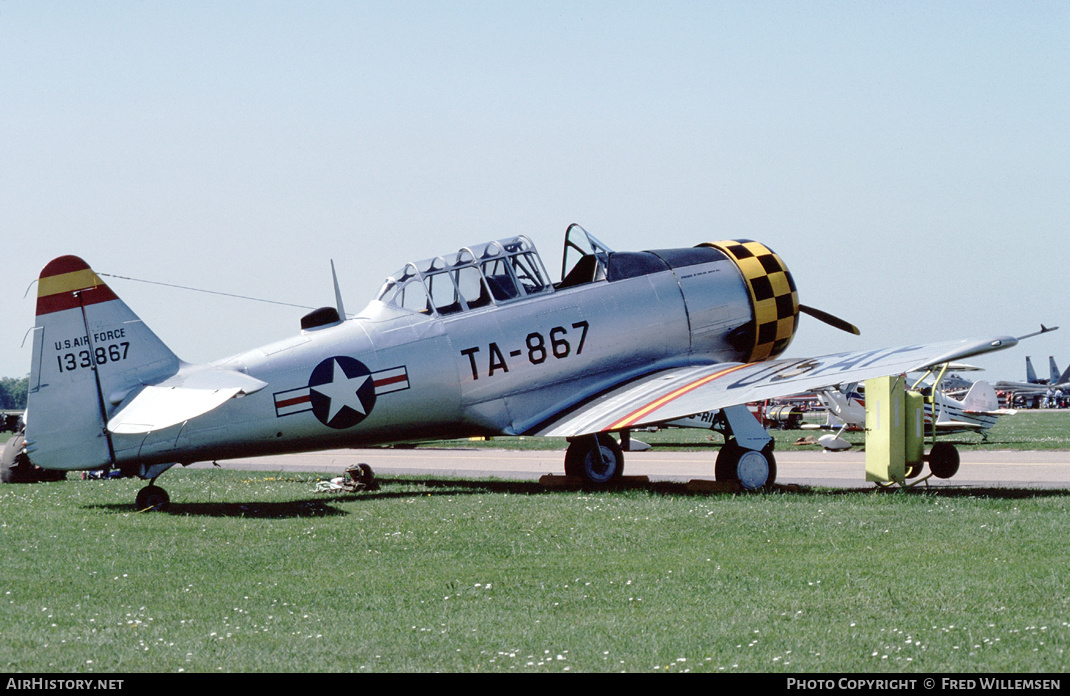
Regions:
[[3, 225, 1018, 510]]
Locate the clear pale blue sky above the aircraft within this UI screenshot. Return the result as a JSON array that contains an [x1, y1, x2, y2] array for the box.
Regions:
[[0, 0, 1070, 379]]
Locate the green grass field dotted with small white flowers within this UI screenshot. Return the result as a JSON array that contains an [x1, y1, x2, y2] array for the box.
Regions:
[[0, 414, 1070, 674]]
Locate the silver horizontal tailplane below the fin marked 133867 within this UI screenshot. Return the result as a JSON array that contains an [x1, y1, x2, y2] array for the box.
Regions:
[[108, 367, 268, 435]]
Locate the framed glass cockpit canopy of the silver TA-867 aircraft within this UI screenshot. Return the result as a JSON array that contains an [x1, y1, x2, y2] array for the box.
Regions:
[[376, 236, 553, 315]]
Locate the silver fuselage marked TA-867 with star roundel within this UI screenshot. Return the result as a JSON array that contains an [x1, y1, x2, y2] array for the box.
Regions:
[[111, 246, 751, 465]]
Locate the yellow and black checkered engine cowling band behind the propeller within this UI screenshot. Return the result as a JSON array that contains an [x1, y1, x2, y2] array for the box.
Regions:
[[701, 239, 799, 362]]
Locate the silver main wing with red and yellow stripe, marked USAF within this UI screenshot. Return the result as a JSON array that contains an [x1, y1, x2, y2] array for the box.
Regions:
[[532, 336, 1018, 437]]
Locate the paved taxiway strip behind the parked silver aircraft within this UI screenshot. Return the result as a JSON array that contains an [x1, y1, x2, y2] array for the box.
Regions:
[[194, 449, 1070, 490]]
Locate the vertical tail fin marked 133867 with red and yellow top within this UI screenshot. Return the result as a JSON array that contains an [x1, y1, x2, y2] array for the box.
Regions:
[[26, 256, 180, 469]]
